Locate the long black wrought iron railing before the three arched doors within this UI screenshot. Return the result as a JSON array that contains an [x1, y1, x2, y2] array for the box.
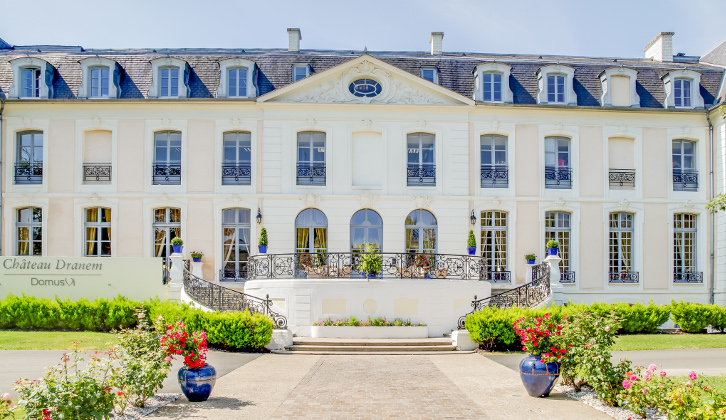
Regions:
[[247, 252, 489, 280]]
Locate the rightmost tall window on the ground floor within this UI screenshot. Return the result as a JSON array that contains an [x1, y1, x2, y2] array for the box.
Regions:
[[673, 213, 703, 282]]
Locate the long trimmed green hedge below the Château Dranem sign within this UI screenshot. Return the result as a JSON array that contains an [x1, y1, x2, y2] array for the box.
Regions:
[[0, 295, 274, 350]]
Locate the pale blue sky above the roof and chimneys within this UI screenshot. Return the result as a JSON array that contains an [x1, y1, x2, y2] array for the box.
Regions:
[[0, 0, 726, 57]]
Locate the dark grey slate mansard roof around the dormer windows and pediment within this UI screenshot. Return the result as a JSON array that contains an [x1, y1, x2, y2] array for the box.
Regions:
[[0, 46, 724, 108]]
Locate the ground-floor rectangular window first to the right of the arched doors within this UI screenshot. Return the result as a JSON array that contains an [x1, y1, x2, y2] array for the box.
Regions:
[[480, 211, 510, 281]]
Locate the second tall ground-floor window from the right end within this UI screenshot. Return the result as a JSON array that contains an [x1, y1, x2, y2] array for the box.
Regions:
[[610, 213, 638, 283]]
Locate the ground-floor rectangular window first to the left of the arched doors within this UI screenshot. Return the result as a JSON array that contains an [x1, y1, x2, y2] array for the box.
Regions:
[[222, 209, 250, 280]]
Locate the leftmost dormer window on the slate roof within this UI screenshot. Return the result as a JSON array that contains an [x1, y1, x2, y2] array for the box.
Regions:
[[8, 57, 55, 99]]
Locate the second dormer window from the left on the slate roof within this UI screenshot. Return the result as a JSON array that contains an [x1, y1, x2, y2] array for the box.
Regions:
[[78, 57, 121, 99]]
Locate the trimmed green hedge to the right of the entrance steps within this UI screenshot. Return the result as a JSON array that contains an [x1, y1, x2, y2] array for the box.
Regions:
[[466, 301, 726, 350]]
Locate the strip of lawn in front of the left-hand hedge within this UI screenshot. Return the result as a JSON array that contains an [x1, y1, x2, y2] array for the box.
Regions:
[[0, 331, 116, 350]]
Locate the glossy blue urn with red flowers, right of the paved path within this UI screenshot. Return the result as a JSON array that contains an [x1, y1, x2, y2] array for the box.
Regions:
[[514, 313, 567, 397]]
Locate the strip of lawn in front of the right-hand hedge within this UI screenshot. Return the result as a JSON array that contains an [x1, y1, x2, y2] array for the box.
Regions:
[[612, 334, 726, 351]]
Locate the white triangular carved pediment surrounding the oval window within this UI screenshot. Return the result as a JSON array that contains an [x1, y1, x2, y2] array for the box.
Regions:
[[258, 54, 474, 106]]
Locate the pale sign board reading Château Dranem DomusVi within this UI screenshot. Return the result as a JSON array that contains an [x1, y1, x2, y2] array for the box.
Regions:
[[0, 256, 166, 300]]
